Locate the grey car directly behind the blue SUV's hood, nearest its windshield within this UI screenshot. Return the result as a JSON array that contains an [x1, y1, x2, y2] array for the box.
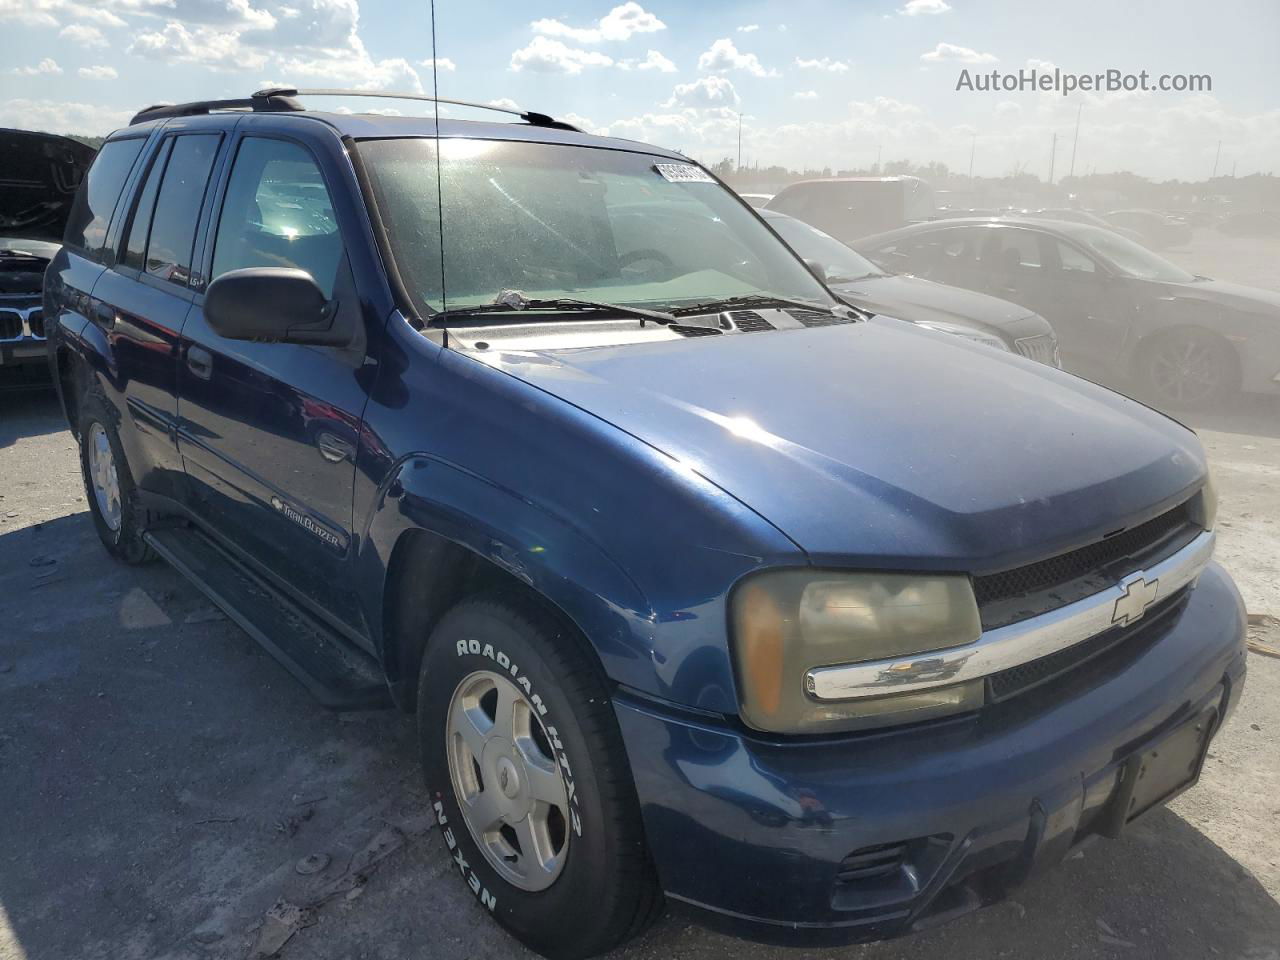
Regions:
[[760, 210, 1061, 366]]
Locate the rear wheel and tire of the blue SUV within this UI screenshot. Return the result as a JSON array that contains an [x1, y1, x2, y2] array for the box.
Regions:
[[79, 394, 156, 564]]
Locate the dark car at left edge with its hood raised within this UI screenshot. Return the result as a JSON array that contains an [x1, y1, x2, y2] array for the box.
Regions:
[[0, 129, 95, 387]]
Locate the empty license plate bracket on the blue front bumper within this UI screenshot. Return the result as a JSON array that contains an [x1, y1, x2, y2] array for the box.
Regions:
[[1098, 707, 1217, 837]]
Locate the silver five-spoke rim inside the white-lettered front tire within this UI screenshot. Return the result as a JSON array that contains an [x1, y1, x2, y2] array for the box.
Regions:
[[445, 671, 570, 891]]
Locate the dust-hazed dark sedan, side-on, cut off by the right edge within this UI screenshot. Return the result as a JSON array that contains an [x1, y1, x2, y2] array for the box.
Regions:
[[855, 219, 1280, 408]]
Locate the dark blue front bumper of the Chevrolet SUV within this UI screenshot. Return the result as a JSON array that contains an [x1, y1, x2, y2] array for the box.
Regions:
[[616, 564, 1244, 942]]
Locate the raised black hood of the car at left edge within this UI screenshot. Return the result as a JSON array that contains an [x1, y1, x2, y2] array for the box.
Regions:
[[0, 129, 97, 243]]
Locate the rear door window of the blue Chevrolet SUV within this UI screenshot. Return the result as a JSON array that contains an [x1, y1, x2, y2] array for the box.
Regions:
[[145, 133, 221, 285]]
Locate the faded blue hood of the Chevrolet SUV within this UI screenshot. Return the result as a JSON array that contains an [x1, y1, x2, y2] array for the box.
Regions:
[[470, 324, 1206, 573]]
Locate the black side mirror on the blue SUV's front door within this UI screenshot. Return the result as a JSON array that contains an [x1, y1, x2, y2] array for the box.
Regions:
[[205, 266, 351, 347]]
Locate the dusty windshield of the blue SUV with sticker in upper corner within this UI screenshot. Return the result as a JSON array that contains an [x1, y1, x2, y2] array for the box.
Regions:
[[360, 138, 833, 316]]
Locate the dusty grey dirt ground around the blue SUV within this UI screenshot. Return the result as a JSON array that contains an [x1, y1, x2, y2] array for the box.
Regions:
[[0, 227, 1280, 960]]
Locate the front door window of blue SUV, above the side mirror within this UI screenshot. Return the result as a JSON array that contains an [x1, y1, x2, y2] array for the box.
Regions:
[[211, 137, 342, 297]]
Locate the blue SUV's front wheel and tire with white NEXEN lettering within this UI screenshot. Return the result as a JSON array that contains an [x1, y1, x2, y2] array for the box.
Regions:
[[417, 595, 662, 960]]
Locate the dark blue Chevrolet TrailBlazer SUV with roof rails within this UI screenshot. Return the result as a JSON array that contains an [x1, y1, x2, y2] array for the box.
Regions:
[[45, 90, 1244, 957]]
